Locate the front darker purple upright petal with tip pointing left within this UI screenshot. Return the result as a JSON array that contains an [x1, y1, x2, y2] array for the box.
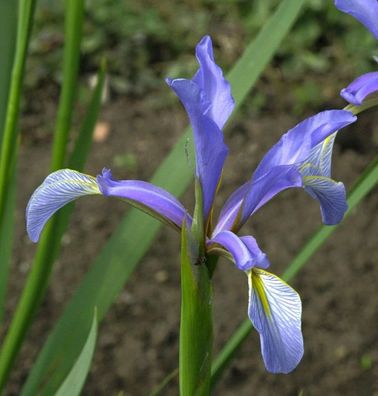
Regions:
[[167, 79, 228, 221]]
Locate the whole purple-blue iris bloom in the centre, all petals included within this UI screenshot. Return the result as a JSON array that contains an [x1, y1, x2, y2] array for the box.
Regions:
[[26, 36, 356, 373]]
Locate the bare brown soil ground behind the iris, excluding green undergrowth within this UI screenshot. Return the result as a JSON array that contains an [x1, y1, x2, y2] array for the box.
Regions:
[[3, 72, 378, 396]]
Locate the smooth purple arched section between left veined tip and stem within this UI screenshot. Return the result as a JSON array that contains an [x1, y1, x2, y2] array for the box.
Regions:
[[97, 169, 191, 229]]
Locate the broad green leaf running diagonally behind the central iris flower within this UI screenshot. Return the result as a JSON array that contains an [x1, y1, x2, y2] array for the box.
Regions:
[[22, 0, 304, 395]]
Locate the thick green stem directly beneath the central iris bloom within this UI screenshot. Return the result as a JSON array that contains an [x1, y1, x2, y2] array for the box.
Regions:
[[179, 225, 213, 396]]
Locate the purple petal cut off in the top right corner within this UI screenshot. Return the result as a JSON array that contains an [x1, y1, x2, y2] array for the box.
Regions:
[[335, 0, 378, 39]]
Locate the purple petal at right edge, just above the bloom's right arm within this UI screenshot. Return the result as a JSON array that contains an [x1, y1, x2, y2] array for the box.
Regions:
[[340, 71, 378, 106]]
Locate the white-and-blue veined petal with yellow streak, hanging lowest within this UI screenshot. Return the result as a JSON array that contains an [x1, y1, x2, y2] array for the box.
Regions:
[[248, 268, 303, 374]]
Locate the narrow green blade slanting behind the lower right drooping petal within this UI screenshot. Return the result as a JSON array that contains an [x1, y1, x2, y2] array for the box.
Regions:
[[212, 158, 378, 385]]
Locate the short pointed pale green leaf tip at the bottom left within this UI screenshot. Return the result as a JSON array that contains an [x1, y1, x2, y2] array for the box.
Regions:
[[55, 311, 97, 396]]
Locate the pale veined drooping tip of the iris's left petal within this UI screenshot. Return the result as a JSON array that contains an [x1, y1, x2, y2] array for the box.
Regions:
[[26, 169, 101, 242]]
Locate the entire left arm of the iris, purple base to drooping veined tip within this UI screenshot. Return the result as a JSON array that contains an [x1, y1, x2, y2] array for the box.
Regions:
[[26, 169, 191, 242]]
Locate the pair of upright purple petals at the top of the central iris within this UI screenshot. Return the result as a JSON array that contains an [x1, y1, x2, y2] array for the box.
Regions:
[[166, 36, 234, 220]]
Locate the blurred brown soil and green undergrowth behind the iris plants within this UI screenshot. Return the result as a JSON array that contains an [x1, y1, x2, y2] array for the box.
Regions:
[[7, 0, 378, 396]]
